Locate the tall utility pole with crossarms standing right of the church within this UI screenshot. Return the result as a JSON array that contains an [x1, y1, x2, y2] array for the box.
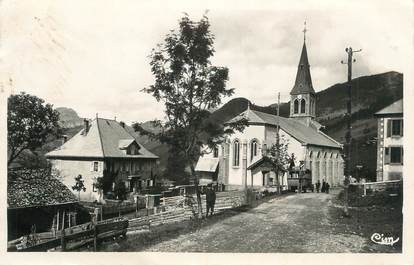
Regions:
[[341, 47, 361, 217]]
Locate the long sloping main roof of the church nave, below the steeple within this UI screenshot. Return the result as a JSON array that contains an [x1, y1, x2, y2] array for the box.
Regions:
[[227, 109, 342, 148]]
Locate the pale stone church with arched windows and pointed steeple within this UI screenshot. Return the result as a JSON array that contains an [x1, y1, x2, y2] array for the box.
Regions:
[[196, 33, 344, 190]]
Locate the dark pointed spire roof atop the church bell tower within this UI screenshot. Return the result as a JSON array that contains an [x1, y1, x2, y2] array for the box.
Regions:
[[290, 42, 315, 95]]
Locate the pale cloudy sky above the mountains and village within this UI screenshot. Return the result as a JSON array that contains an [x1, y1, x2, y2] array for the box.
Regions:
[[0, 0, 413, 123]]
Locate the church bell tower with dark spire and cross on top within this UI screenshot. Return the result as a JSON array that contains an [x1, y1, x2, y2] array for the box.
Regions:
[[290, 22, 316, 124]]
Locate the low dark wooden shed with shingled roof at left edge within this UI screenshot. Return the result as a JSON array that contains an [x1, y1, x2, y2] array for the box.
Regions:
[[7, 169, 90, 240]]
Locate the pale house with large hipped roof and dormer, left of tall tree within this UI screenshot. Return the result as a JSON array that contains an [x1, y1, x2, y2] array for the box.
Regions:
[[46, 117, 158, 202]]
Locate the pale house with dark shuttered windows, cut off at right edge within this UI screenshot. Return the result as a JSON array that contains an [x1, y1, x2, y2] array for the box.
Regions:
[[375, 99, 404, 181]]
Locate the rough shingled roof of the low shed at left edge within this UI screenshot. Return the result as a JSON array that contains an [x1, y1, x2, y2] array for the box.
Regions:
[[7, 170, 77, 209]]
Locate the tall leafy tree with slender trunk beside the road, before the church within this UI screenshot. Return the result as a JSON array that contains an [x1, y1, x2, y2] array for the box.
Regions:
[[134, 14, 246, 215]]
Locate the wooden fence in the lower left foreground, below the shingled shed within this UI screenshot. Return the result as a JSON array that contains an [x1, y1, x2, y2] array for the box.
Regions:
[[8, 218, 128, 252]]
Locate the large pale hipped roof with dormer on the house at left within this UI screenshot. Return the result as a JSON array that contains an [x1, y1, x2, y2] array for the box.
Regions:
[[46, 118, 158, 159]]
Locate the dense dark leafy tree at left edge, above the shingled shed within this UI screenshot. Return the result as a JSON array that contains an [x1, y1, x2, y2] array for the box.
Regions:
[[7, 92, 61, 165]]
